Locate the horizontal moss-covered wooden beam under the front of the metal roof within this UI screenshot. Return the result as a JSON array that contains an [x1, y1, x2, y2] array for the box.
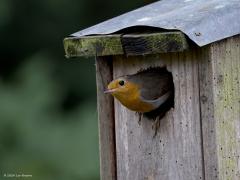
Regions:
[[64, 32, 188, 57]]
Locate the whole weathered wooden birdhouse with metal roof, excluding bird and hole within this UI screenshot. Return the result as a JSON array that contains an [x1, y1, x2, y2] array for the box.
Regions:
[[64, 0, 240, 180]]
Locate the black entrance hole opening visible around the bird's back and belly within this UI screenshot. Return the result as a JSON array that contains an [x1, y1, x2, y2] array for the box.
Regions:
[[141, 67, 175, 119]]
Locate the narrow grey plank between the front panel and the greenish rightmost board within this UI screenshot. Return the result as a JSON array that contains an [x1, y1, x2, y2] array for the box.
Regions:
[[198, 46, 218, 180]]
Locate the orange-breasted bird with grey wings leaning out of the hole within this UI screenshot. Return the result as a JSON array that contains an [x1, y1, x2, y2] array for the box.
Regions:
[[104, 68, 174, 113]]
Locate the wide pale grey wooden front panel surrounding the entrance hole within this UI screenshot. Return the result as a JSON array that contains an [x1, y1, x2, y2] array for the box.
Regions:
[[113, 50, 204, 180]]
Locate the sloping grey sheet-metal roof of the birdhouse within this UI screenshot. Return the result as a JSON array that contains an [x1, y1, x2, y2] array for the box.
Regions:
[[71, 0, 240, 46]]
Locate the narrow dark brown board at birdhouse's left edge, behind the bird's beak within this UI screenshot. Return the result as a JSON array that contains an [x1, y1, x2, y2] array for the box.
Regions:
[[96, 57, 116, 180]]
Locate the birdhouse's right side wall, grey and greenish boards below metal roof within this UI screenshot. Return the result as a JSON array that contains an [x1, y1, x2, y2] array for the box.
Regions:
[[200, 36, 240, 180]]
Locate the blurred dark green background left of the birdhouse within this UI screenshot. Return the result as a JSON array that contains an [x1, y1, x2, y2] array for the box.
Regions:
[[0, 0, 144, 180]]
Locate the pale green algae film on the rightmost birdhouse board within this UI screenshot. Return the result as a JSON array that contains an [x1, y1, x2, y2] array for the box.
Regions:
[[214, 44, 239, 179]]
